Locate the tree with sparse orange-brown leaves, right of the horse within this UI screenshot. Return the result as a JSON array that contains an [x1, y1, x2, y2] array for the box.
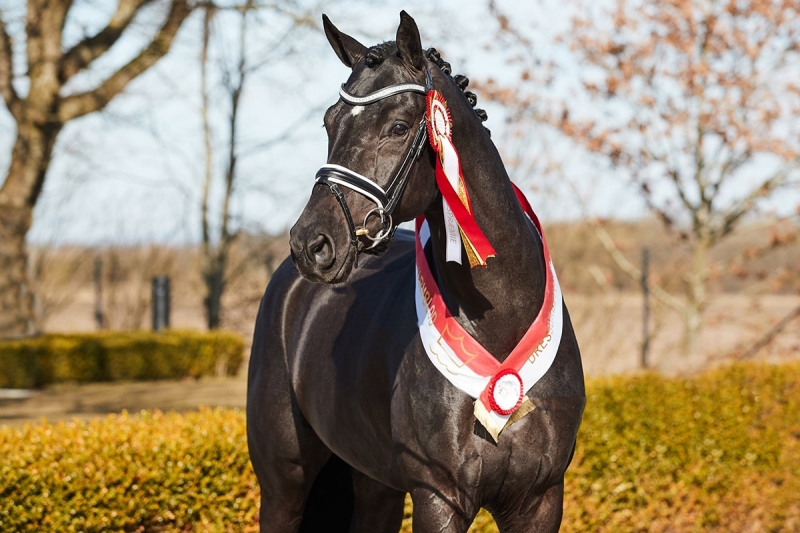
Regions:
[[484, 0, 800, 354]]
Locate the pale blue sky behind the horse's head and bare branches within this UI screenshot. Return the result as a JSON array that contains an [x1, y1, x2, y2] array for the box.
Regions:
[[0, 0, 789, 244]]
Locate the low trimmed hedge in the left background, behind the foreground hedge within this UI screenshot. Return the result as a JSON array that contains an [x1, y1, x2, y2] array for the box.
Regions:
[[0, 330, 244, 388]]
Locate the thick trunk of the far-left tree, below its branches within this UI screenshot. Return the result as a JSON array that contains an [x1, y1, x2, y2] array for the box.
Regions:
[[0, 122, 61, 338]]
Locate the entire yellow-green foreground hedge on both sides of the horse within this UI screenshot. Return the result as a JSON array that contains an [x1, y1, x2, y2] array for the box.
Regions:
[[0, 363, 800, 533]]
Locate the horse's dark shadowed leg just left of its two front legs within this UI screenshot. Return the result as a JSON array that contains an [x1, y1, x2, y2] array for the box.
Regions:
[[350, 469, 406, 533]]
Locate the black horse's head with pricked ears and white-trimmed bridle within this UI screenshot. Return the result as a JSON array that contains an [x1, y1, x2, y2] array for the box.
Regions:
[[290, 11, 474, 283]]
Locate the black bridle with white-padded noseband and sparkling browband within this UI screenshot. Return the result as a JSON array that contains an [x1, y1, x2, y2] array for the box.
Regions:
[[315, 69, 433, 266]]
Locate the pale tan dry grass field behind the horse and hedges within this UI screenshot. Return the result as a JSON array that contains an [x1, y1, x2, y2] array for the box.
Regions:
[[40, 288, 800, 376]]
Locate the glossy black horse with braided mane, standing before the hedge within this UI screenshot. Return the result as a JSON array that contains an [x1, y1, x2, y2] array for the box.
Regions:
[[247, 12, 585, 533]]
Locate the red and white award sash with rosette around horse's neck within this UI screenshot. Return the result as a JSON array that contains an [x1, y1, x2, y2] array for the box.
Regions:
[[416, 183, 563, 441]]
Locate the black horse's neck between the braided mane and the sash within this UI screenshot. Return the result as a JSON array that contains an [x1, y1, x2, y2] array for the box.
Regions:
[[425, 83, 545, 361]]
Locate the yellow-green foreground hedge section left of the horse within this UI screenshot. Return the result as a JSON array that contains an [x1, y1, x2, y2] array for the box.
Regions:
[[0, 409, 259, 532]]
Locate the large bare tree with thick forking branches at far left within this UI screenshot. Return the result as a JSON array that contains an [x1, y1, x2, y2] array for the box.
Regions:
[[0, 0, 190, 336]]
